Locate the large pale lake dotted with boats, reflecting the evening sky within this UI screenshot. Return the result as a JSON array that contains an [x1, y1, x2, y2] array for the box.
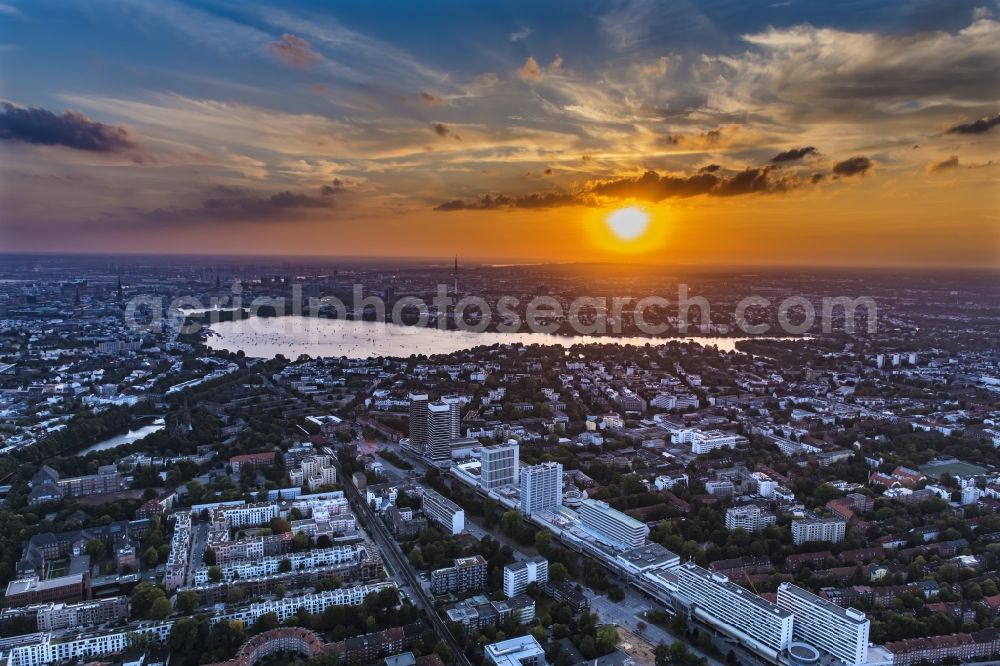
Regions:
[[207, 316, 801, 359]]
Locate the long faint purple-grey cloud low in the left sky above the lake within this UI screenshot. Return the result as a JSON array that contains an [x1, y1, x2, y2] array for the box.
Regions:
[[141, 187, 339, 222]]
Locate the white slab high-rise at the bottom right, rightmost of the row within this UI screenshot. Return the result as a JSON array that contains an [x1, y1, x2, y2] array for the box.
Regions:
[[778, 583, 871, 666]]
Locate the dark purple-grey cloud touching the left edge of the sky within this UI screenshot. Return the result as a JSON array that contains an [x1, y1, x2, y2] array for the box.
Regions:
[[0, 102, 135, 153]]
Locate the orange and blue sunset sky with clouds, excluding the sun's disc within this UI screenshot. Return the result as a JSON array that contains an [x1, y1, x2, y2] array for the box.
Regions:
[[0, 0, 1000, 267]]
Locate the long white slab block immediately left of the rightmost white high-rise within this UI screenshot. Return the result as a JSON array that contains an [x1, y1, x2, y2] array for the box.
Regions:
[[675, 562, 792, 661]]
